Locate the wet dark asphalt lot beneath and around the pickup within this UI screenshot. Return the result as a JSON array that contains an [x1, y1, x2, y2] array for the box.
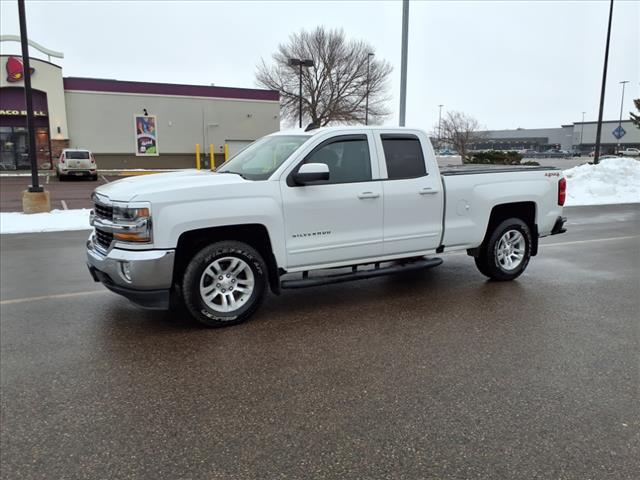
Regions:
[[0, 205, 640, 479]]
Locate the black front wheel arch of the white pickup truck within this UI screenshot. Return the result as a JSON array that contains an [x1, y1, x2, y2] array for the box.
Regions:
[[173, 223, 280, 294]]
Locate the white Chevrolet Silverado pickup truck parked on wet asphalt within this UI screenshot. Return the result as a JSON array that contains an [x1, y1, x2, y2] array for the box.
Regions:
[[87, 127, 566, 327]]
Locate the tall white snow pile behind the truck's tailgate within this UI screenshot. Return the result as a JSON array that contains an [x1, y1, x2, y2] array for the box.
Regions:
[[564, 157, 640, 206]]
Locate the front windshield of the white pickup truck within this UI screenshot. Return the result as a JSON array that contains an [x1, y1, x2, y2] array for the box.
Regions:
[[216, 135, 310, 180]]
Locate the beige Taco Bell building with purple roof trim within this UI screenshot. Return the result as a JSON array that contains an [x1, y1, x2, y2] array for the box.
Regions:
[[0, 44, 280, 170]]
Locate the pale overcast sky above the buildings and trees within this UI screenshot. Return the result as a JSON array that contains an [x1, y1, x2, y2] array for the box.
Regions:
[[0, 0, 640, 129]]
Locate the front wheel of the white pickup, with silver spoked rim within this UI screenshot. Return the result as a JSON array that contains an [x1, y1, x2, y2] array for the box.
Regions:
[[182, 241, 268, 327]]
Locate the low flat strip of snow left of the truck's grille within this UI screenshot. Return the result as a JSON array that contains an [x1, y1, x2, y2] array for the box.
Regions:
[[0, 208, 91, 234]]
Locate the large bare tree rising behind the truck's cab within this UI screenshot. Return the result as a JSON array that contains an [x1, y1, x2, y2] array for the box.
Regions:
[[256, 27, 392, 126]]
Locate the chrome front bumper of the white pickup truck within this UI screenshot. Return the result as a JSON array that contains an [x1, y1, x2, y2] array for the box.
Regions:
[[87, 235, 175, 310]]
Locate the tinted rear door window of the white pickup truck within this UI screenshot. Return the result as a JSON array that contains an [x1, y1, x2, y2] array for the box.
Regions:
[[381, 135, 427, 180]]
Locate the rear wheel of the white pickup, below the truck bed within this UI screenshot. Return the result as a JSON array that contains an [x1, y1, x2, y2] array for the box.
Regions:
[[475, 218, 532, 281]]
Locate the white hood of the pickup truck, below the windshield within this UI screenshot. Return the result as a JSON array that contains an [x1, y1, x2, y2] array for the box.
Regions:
[[96, 169, 250, 202]]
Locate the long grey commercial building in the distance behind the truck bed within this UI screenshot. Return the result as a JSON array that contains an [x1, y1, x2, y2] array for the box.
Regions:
[[473, 120, 640, 153]]
